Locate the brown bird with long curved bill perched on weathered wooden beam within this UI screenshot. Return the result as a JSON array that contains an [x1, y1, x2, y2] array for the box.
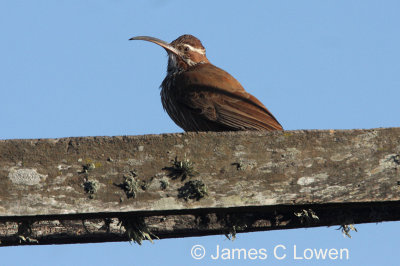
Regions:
[[130, 35, 283, 131]]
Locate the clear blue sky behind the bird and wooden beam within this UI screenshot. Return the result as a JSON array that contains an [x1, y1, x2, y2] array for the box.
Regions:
[[0, 0, 400, 265]]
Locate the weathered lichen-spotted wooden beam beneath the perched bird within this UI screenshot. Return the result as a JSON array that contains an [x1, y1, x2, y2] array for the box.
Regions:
[[0, 128, 400, 244]]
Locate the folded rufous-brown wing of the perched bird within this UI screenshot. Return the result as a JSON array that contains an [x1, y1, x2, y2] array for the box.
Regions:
[[176, 64, 282, 130]]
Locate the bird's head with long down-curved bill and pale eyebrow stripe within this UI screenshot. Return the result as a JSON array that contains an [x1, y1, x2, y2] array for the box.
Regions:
[[129, 34, 209, 74]]
